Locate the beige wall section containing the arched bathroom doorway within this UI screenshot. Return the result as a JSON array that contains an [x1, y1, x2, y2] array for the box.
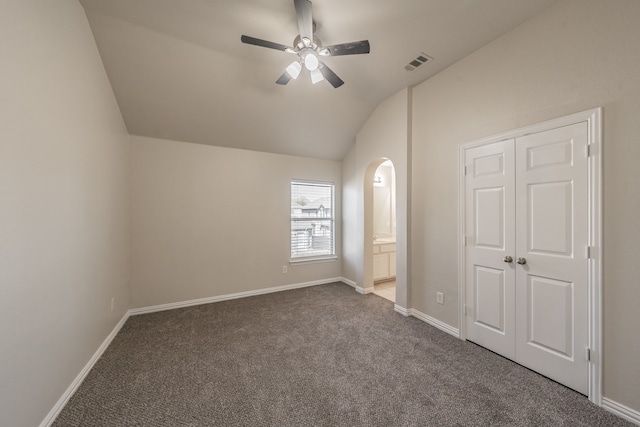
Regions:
[[342, 89, 411, 308]]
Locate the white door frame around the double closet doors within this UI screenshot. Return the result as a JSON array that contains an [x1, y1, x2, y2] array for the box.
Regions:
[[458, 107, 603, 406]]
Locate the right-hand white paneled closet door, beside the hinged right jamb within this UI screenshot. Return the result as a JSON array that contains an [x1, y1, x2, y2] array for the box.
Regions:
[[515, 122, 589, 394]]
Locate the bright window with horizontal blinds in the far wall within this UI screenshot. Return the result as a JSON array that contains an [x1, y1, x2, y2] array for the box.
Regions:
[[291, 181, 335, 260]]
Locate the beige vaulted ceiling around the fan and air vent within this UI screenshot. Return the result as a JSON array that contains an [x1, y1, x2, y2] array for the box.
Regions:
[[81, 0, 558, 160]]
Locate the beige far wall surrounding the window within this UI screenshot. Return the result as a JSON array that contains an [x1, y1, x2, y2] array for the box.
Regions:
[[131, 136, 342, 308]]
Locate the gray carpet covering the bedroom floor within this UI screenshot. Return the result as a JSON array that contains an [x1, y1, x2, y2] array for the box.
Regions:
[[54, 283, 631, 426]]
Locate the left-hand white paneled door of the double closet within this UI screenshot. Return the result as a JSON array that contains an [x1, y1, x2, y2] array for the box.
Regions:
[[465, 140, 515, 359]]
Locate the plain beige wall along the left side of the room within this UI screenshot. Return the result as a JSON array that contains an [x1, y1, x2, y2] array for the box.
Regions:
[[0, 0, 129, 427]]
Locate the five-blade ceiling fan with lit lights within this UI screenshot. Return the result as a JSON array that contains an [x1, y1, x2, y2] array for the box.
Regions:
[[240, 0, 370, 88]]
